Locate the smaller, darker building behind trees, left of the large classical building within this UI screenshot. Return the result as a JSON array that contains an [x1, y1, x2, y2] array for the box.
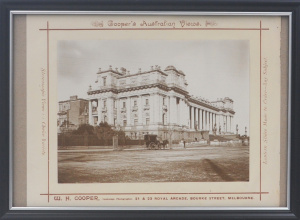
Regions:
[[57, 96, 89, 130]]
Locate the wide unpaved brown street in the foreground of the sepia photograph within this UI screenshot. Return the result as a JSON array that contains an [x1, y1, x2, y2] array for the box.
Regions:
[[58, 145, 249, 183]]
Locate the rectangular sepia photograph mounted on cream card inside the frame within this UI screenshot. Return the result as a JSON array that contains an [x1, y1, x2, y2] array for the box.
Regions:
[[57, 40, 250, 184]]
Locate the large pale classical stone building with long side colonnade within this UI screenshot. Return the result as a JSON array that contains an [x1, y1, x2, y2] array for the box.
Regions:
[[88, 66, 235, 140]]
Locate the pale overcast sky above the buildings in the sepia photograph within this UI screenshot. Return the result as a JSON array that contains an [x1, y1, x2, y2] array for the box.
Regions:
[[58, 40, 250, 134]]
